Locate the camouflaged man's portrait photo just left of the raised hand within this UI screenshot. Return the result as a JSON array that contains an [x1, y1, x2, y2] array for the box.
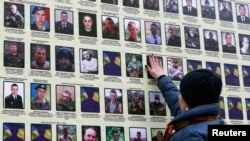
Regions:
[[125, 53, 143, 78]]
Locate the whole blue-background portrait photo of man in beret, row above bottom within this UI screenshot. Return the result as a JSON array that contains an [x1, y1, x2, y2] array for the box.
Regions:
[[31, 83, 51, 110]]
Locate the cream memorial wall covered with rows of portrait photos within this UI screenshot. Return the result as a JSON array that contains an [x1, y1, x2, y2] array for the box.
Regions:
[[0, 0, 250, 141]]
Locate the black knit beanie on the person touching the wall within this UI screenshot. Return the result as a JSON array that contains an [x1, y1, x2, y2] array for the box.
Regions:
[[180, 69, 222, 108]]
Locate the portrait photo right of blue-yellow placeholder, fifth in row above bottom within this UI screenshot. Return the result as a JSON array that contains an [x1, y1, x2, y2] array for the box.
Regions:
[[104, 88, 123, 114]]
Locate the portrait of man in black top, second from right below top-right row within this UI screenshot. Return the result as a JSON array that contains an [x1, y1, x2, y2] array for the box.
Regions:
[[221, 32, 236, 54]]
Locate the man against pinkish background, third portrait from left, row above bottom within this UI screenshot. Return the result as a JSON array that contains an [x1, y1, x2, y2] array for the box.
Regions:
[[56, 90, 75, 111]]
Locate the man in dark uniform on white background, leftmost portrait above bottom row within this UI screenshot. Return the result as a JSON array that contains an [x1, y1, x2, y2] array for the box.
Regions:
[[4, 83, 23, 109]]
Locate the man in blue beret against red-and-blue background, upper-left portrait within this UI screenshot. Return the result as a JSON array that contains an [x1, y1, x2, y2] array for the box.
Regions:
[[31, 6, 50, 32]]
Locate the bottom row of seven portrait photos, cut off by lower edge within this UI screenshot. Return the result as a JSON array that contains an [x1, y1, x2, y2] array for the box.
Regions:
[[3, 123, 165, 141]]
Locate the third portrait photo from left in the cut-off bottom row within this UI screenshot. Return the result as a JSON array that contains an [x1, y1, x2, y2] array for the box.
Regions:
[[56, 124, 77, 141]]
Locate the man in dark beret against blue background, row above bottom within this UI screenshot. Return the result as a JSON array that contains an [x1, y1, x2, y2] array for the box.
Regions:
[[31, 84, 50, 110]]
